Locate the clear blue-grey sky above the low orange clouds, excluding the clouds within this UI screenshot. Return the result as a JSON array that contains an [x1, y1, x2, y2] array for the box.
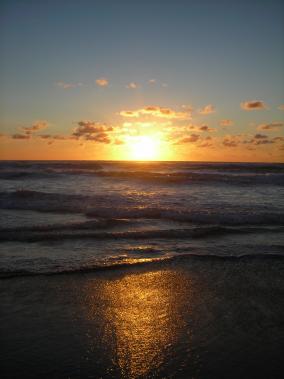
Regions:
[[0, 0, 284, 161]]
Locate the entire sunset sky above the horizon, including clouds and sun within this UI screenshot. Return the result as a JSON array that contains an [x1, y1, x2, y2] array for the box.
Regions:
[[0, 0, 284, 162]]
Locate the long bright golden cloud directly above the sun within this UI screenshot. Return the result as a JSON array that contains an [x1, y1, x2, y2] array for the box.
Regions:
[[119, 106, 190, 119]]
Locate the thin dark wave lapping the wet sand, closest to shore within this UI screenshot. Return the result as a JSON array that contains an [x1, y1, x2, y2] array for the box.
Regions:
[[0, 254, 284, 279]]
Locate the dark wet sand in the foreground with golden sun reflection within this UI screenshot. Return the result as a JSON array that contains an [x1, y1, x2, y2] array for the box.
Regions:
[[0, 258, 284, 379]]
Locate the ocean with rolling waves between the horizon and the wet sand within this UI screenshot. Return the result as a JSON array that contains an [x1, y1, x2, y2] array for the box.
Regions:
[[0, 161, 284, 277]]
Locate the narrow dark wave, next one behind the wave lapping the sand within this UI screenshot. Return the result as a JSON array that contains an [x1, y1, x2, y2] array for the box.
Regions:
[[0, 226, 284, 242]]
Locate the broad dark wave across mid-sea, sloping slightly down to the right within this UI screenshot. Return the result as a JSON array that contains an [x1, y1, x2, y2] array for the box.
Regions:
[[0, 190, 284, 226]]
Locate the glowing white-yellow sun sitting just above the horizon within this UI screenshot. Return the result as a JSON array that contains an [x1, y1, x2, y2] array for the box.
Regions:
[[129, 136, 160, 161]]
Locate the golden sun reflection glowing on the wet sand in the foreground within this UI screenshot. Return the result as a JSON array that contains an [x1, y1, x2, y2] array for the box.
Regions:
[[83, 270, 190, 378]]
